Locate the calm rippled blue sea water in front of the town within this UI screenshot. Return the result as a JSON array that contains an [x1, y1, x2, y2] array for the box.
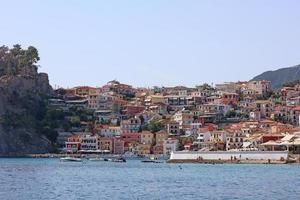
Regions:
[[0, 158, 300, 200]]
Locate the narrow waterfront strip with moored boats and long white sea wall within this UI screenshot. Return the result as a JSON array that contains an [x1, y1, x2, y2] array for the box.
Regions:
[[26, 151, 300, 164]]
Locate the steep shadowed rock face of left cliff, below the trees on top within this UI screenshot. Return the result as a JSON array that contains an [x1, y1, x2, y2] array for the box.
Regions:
[[0, 73, 52, 155]]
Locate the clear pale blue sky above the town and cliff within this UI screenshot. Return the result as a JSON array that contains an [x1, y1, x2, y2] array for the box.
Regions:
[[0, 0, 300, 88]]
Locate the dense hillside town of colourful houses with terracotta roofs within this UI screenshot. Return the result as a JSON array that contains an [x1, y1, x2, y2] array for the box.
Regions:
[[50, 80, 300, 156]]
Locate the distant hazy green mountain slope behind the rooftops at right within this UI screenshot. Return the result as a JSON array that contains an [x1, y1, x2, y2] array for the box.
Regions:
[[252, 65, 300, 89]]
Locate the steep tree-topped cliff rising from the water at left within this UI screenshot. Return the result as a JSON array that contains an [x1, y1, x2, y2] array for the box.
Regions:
[[0, 45, 52, 156]]
